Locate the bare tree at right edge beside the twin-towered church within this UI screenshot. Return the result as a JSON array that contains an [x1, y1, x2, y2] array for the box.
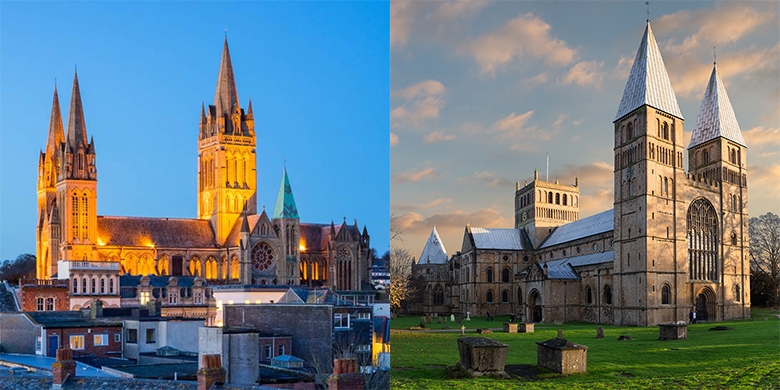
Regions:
[[748, 213, 780, 304]]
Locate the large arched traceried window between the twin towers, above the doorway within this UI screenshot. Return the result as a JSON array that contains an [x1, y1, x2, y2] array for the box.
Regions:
[[687, 198, 718, 281]]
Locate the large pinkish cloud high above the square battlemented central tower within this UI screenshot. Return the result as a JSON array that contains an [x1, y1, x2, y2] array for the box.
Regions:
[[460, 13, 576, 76]]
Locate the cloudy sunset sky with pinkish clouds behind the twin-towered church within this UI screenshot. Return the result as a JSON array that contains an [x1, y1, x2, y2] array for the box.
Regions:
[[390, 1, 780, 257]]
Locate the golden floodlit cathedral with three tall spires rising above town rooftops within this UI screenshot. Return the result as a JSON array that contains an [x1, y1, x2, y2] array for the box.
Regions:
[[36, 39, 371, 290]]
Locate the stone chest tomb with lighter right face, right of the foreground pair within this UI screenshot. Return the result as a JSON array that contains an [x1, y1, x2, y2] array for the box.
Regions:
[[536, 338, 588, 375]]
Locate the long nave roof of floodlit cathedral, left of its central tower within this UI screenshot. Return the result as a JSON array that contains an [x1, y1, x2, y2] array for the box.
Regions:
[[98, 216, 215, 248]]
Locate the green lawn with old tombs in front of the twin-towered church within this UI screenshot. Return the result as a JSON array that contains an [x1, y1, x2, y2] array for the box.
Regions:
[[391, 309, 780, 389]]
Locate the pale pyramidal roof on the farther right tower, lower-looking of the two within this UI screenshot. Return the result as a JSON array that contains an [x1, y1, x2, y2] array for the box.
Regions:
[[688, 64, 747, 148]]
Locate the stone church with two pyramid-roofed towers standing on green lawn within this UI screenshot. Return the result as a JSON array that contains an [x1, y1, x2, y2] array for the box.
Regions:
[[412, 20, 750, 326]]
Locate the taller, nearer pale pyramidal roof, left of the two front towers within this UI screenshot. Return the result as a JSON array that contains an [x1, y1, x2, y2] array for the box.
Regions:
[[615, 20, 683, 121]]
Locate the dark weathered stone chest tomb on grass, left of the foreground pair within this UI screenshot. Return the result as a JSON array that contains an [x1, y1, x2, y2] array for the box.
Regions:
[[458, 337, 509, 378]]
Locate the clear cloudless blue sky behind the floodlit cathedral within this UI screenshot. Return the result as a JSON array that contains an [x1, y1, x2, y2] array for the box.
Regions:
[[0, 2, 390, 259]]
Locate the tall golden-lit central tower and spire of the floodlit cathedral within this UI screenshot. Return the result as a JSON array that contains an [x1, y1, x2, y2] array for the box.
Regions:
[[198, 37, 257, 245]]
